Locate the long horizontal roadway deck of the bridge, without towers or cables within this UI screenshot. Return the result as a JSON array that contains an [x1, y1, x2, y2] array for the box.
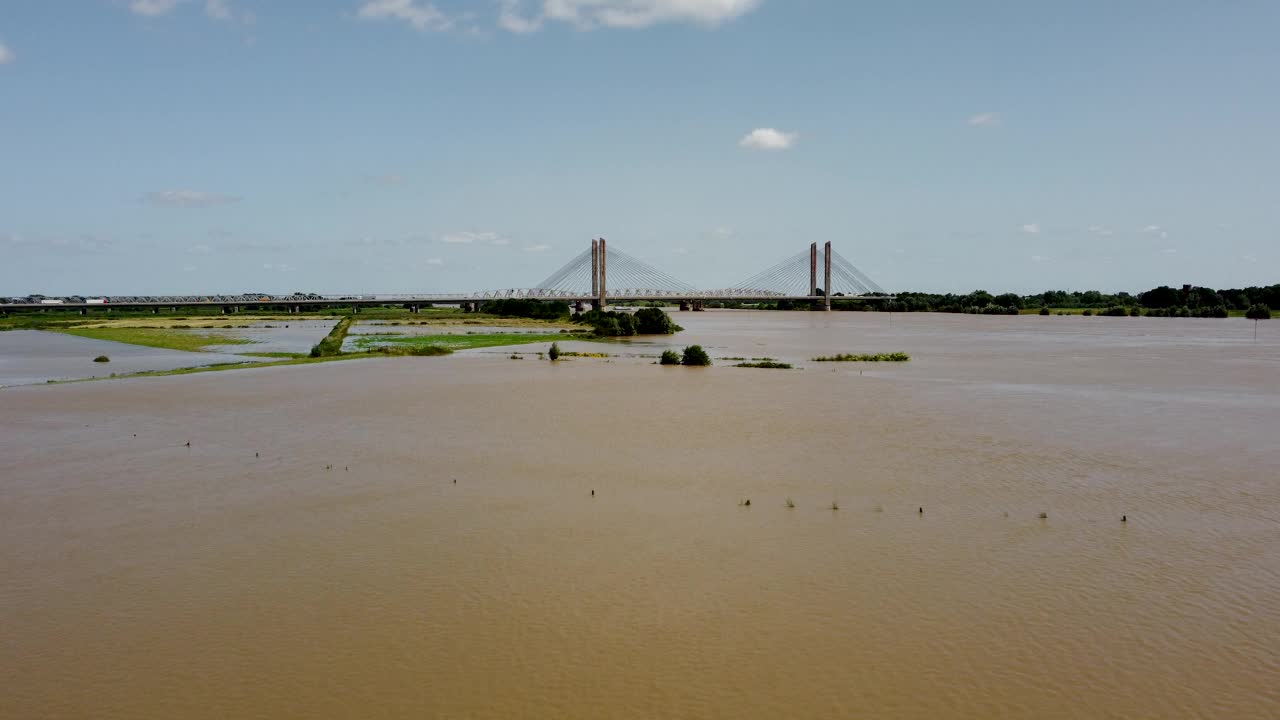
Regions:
[[0, 292, 893, 313]]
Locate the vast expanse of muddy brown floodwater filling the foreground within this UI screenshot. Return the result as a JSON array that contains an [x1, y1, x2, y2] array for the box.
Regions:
[[0, 313, 1280, 719]]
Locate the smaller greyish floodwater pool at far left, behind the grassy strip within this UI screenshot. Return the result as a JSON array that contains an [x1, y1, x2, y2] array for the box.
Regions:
[[0, 331, 267, 387]]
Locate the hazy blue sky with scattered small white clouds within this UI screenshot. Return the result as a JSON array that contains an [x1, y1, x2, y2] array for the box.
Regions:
[[0, 0, 1280, 295]]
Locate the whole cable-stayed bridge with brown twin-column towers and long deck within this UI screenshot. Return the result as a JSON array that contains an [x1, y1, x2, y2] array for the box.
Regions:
[[0, 238, 890, 313]]
